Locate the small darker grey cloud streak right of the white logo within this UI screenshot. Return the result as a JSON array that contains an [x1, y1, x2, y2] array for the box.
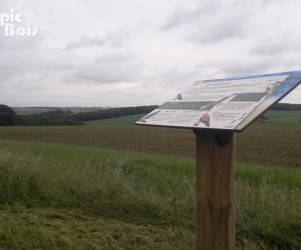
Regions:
[[65, 28, 130, 50]]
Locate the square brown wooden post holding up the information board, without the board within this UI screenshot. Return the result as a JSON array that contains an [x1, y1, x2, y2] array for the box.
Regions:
[[195, 129, 235, 250]]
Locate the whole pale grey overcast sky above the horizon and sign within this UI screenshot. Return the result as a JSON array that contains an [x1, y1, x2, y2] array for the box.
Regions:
[[0, 0, 301, 107]]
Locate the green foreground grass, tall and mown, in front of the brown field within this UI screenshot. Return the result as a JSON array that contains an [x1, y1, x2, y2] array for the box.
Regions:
[[0, 141, 301, 249]]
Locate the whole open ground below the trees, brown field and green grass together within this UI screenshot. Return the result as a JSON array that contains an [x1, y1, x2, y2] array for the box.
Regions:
[[0, 113, 301, 250]]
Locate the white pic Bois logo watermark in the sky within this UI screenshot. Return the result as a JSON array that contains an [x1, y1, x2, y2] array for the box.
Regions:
[[0, 9, 39, 37]]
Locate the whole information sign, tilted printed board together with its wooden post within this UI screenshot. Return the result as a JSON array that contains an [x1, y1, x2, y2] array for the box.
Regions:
[[136, 71, 301, 250]]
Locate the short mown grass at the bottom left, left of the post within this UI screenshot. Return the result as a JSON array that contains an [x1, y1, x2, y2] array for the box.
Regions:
[[0, 203, 193, 250]]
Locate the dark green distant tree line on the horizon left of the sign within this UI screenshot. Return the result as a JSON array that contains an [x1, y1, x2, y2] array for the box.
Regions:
[[0, 104, 158, 126]]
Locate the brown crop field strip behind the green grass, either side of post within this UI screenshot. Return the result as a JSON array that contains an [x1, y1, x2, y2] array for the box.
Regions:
[[0, 121, 301, 168]]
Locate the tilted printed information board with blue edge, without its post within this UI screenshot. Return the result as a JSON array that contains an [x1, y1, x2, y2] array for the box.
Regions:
[[136, 71, 301, 131]]
